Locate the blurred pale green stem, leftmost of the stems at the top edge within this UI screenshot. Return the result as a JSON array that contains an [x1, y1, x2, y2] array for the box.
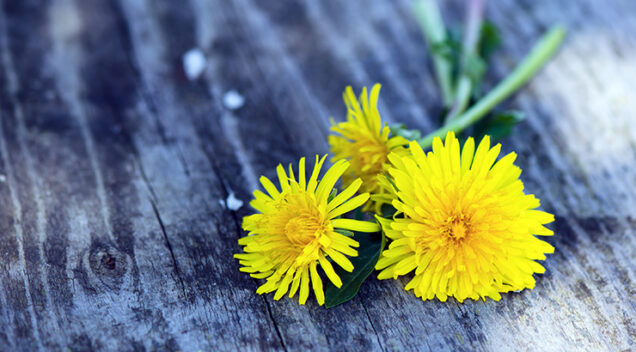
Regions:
[[414, 0, 453, 107]]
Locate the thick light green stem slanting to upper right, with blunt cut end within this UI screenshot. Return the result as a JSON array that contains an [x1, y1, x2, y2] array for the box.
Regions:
[[420, 26, 565, 148]]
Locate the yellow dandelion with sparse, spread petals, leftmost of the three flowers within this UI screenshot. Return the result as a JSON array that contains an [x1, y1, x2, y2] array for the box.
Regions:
[[234, 155, 380, 305]]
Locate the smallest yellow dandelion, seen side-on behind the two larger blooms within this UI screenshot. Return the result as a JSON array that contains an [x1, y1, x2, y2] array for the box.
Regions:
[[329, 84, 408, 212]]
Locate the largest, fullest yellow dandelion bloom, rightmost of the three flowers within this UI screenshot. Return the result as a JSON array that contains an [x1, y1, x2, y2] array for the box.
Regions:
[[376, 132, 554, 302]]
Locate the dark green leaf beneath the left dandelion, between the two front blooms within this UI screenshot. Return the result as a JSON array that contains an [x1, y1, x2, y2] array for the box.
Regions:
[[325, 231, 385, 308]]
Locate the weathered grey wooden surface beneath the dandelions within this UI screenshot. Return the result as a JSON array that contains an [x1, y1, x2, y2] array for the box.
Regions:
[[0, 0, 636, 351]]
